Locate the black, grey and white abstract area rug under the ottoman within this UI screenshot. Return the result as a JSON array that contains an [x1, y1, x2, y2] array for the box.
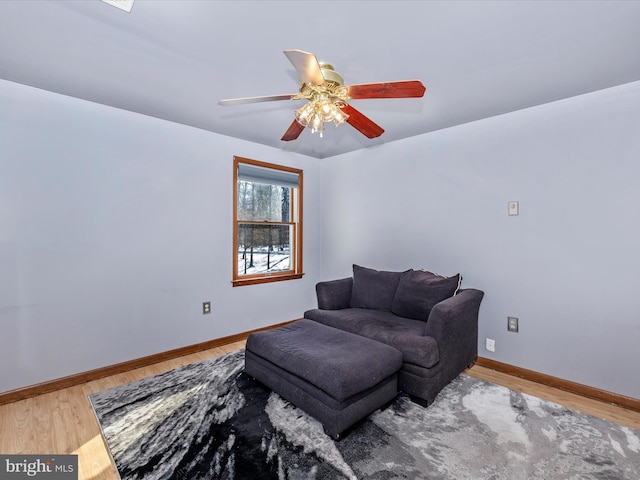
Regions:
[[89, 351, 640, 480]]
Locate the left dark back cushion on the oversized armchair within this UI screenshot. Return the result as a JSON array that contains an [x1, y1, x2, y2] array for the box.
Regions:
[[350, 265, 403, 310]]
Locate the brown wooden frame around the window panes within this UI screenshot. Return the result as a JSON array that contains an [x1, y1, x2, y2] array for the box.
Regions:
[[231, 156, 304, 287]]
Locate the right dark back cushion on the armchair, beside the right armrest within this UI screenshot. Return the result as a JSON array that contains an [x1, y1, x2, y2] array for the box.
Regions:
[[391, 270, 462, 322]]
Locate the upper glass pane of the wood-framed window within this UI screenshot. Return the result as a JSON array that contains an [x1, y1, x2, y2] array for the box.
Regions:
[[238, 180, 292, 222]]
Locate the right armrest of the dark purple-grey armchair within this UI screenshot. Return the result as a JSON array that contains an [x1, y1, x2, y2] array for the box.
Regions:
[[425, 288, 484, 380]]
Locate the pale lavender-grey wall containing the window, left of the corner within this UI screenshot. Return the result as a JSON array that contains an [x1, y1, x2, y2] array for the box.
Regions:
[[0, 81, 320, 392]]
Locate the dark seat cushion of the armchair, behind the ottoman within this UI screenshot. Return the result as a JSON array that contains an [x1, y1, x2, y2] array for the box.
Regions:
[[304, 308, 440, 368]]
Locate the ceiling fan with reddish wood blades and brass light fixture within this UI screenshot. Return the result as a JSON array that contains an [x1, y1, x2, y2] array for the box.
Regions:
[[218, 50, 426, 141]]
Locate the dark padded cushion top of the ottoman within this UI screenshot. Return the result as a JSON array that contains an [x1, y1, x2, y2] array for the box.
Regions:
[[246, 320, 402, 402]]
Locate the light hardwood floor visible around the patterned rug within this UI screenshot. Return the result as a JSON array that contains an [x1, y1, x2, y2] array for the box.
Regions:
[[0, 341, 640, 480]]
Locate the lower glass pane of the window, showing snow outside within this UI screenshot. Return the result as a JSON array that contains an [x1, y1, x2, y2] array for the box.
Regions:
[[238, 223, 293, 275]]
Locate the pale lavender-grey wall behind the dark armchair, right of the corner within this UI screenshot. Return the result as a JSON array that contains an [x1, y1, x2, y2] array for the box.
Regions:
[[322, 82, 640, 398]]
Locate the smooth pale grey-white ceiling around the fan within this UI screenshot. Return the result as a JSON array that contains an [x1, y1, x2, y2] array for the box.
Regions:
[[0, 0, 640, 158]]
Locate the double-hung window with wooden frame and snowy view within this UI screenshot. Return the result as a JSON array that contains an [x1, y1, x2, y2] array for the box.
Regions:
[[233, 157, 302, 286]]
